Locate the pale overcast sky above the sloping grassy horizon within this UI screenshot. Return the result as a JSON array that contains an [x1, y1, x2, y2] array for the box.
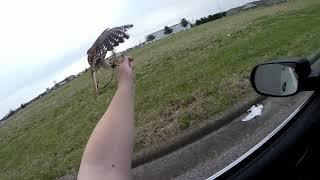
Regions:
[[0, 0, 252, 118]]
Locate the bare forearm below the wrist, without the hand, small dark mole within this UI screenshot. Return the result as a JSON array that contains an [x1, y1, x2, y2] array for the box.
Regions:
[[80, 85, 134, 179]]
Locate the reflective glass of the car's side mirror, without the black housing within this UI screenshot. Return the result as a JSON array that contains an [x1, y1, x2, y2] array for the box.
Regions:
[[254, 64, 298, 96]]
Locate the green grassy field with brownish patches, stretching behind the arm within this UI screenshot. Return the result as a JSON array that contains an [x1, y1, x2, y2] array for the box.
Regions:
[[0, 0, 320, 179]]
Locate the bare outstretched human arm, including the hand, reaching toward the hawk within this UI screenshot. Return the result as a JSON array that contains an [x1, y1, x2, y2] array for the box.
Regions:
[[78, 57, 134, 180]]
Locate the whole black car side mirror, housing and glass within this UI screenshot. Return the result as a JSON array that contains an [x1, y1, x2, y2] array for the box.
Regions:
[[250, 59, 311, 97]]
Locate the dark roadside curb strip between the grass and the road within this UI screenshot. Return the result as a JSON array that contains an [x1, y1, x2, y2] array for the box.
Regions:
[[132, 94, 267, 168]]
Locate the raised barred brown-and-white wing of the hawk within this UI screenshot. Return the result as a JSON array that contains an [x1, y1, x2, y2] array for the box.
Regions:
[[87, 24, 133, 65]]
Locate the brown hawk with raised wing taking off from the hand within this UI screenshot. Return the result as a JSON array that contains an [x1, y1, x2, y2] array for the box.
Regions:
[[87, 24, 133, 94]]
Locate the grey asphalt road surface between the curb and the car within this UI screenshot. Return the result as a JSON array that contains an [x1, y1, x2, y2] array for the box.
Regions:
[[132, 92, 311, 179]]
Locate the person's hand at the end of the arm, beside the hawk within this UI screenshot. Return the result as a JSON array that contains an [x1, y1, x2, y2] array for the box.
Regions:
[[117, 56, 134, 88]]
